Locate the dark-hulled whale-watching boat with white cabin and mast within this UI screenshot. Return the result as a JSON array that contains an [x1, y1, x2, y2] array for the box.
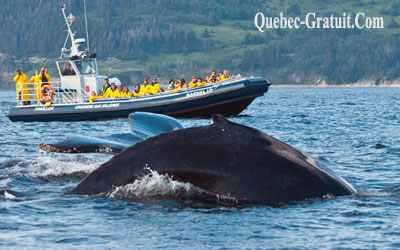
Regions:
[[7, 5, 270, 121]]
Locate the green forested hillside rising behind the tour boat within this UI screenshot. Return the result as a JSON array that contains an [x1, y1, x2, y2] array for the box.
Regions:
[[0, 0, 400, 88]]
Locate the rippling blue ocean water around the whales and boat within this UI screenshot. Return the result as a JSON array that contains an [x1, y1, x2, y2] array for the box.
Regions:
[[0, 88, 400, 249]]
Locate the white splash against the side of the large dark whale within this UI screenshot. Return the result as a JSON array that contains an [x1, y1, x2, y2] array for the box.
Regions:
[[105, 167, 238, 205]]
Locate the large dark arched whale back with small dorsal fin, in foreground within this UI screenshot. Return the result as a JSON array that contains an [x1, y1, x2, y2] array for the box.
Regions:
[[61, 114, 357, 205]]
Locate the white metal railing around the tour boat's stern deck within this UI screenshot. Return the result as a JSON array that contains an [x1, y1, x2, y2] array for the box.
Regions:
[[16, 81, 88, 106]]
